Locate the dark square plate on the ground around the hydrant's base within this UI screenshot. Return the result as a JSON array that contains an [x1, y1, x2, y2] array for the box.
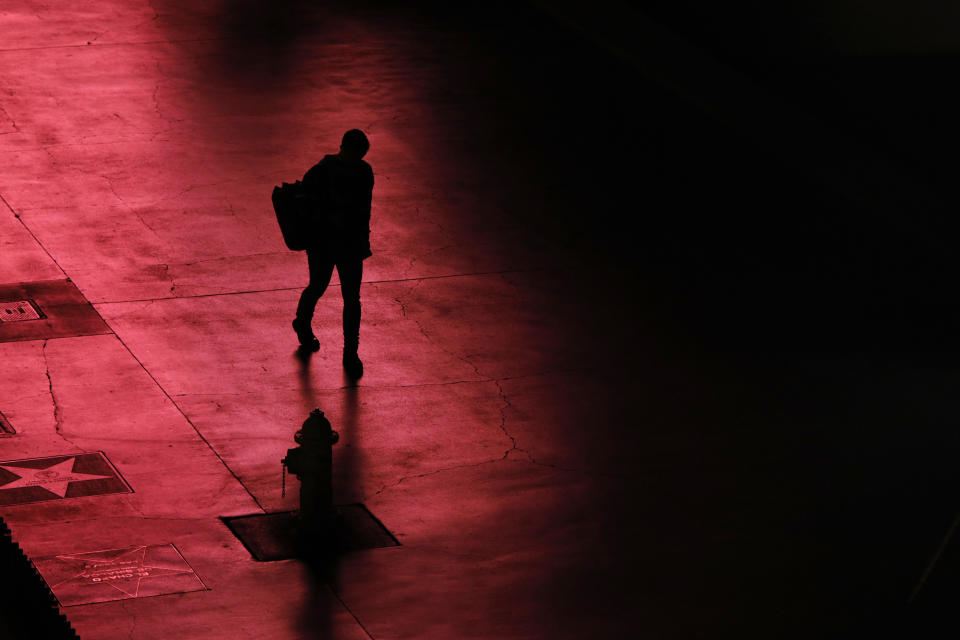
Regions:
[[223, 503, 400, 560]]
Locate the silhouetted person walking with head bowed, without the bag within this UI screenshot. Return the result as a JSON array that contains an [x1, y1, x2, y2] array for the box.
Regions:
[[293, 129, 373, 378]]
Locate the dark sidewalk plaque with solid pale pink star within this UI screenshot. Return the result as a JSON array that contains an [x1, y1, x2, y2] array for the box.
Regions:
[[0, 452, 133, 506]]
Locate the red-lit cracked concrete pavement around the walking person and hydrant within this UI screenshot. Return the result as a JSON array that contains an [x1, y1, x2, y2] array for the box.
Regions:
[[0, 0, 652, 638]]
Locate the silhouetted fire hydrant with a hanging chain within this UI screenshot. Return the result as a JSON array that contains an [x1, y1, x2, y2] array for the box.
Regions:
[[280, 409, 340, 539]]
